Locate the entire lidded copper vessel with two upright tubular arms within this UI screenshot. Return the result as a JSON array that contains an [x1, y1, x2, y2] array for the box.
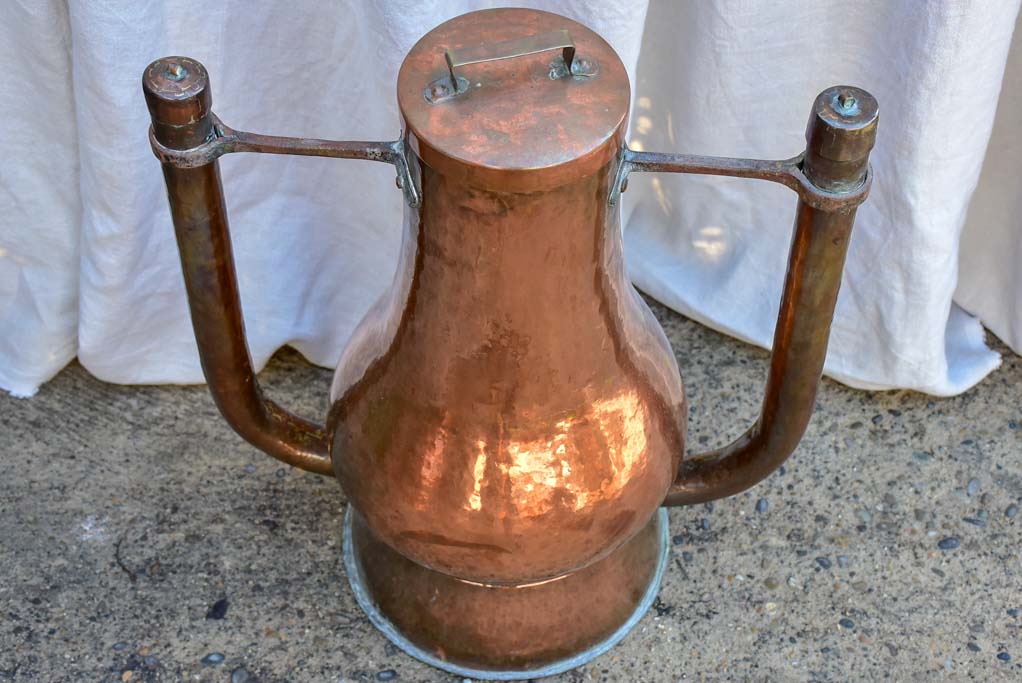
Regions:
[[143, 9, 877, 679]]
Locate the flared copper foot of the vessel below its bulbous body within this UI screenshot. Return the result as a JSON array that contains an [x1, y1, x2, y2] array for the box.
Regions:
[[354, 507, 660, 671]]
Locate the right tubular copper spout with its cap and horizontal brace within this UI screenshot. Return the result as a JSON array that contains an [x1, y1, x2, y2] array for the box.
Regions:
[[630, 86, 878, 505]]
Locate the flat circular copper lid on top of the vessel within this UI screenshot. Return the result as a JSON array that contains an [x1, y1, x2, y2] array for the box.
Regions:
[[398, 8, 631, 191]]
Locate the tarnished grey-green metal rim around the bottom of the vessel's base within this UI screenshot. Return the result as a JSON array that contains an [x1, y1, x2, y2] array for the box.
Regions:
[[343, 504, 669, 681]]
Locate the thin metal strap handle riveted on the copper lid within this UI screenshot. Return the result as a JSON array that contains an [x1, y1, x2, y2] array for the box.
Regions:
[[425, 29, 597, 104]]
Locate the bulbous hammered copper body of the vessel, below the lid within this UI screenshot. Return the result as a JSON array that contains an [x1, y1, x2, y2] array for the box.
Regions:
[[329, 160, 686, 584]]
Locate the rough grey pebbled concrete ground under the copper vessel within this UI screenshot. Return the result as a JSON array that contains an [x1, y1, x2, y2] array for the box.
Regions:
[[0, 300, 1022, 683]]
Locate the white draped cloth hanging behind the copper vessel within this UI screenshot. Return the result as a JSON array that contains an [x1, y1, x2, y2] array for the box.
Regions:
[[0, 0, 1022, 396]]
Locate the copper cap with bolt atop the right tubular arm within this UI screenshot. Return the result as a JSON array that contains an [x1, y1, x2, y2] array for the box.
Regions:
[[803, 86, 880, 191]]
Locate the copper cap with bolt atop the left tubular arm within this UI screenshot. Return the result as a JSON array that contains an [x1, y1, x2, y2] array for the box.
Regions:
[[142, 56, 213, 148]]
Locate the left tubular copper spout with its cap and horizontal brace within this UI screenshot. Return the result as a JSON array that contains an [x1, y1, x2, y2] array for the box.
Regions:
[[142, 57, 408, 474]]
